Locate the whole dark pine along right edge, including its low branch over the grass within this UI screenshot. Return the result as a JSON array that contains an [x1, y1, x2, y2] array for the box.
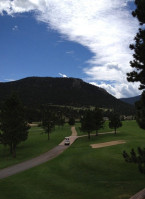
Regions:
[[123, 0, 145, 174]]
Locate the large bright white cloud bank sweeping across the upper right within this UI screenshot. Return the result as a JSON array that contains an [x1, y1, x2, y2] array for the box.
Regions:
[[0, 0, 138, 96]]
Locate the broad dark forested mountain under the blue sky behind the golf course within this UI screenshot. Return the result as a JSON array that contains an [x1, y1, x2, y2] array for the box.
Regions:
[[0, 77, 133, 113]]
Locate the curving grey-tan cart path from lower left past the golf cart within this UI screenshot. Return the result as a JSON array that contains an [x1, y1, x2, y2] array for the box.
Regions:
[[0, 127, 77, 179]]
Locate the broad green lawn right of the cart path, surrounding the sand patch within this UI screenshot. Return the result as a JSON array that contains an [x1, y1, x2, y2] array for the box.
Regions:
[[0, 121, 145, 199]]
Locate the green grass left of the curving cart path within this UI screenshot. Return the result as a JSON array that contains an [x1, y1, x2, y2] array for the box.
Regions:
[[0, 125, 71, 169]]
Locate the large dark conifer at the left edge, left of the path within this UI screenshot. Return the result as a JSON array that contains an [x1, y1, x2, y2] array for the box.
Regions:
[[0, 94, 30, 157]]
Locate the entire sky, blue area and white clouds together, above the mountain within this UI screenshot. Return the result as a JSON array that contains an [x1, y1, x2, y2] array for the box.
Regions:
[[0, 0, 141, 98]]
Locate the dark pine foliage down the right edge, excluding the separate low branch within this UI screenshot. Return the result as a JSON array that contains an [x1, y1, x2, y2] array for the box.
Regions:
[[127, 0, 145, 129]]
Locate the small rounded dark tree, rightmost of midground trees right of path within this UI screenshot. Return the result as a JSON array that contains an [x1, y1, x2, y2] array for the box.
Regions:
[[109, 113, 122, 134]]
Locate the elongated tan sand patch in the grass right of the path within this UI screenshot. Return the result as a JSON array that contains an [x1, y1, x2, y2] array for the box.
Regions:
[[90, 140, 126, 149]]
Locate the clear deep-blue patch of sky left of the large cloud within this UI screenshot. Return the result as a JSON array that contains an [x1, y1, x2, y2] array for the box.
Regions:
[[0, 13, 92, 81]]
